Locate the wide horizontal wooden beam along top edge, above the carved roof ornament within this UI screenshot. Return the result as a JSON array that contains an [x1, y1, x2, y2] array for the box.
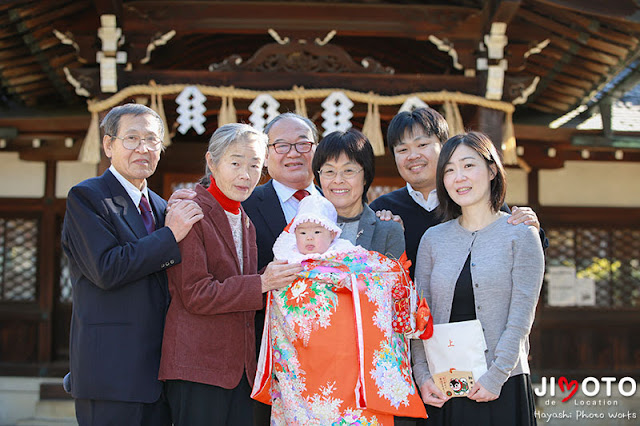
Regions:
[[122, 0, 478, 40]]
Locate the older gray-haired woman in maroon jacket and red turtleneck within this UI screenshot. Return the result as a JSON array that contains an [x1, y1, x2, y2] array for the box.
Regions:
[[159, 123, 302, 426]]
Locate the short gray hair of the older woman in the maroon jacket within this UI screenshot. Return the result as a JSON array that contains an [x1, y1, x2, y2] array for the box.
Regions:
[[200, 123, 269, 186]]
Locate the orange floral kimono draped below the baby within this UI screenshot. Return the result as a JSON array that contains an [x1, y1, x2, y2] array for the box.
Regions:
[[251, 247, 426, 426]]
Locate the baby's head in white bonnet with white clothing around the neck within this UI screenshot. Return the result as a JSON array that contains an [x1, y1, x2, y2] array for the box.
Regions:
[[273, 195, 364, 262]]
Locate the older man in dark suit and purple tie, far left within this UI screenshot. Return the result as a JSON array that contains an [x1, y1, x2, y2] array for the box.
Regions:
[[62, 104, 202, 426]]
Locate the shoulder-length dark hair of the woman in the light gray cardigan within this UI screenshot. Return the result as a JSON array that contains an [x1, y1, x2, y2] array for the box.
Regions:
[[436, 132, 507, 220]]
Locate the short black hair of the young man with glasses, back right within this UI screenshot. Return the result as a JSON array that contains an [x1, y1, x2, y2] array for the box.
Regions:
[[387, 107, 449, 157]]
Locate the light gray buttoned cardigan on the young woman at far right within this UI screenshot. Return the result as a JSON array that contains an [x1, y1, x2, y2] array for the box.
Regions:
[[411, 213, 544, 395]]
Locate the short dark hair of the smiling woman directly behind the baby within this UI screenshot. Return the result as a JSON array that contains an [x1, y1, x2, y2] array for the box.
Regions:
[[311, 128, 376, 203]]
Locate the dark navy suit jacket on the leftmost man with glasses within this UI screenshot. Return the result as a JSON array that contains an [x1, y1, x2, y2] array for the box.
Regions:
[[62, 170, 181, 403]]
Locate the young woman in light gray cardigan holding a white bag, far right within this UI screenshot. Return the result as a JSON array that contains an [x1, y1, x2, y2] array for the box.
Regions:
[[412, 132, 544, 426]]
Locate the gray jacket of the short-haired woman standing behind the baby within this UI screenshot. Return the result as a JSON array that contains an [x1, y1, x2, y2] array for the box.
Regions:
[[356, 204, 404, 259]]
